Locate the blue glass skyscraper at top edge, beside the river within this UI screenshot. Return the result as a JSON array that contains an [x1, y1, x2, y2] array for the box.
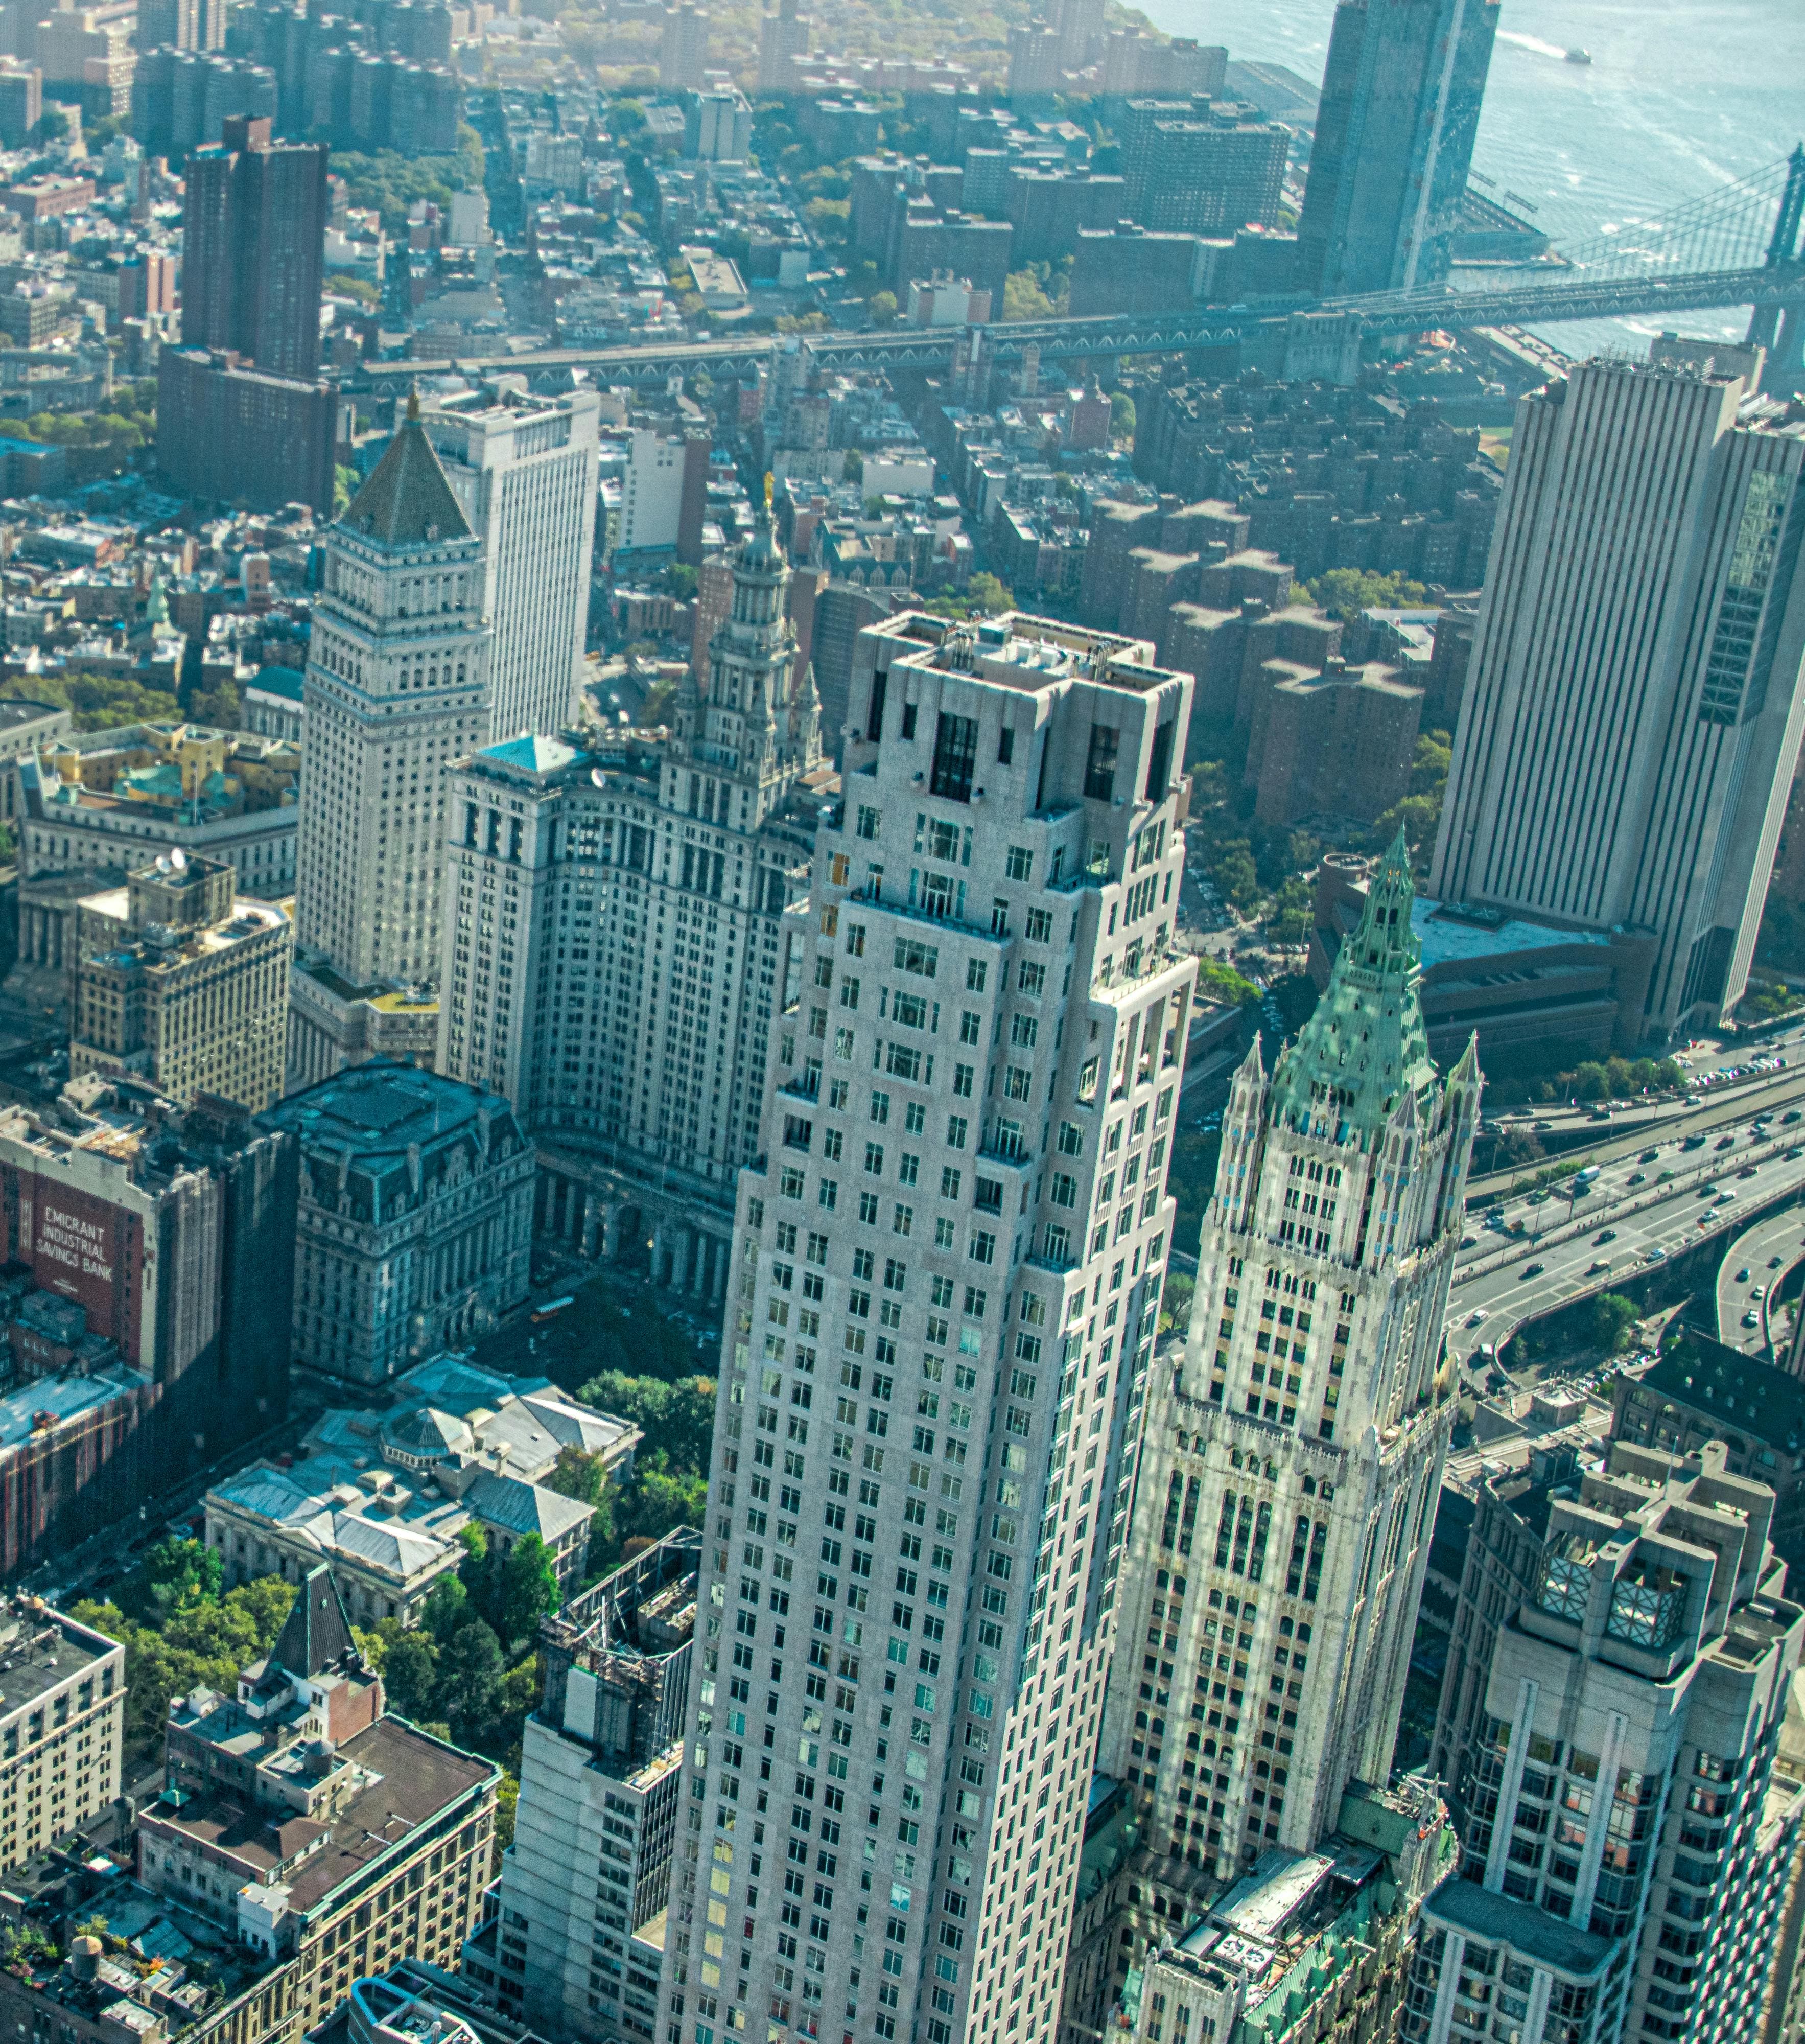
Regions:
[[1298, 0, 1498, 296]]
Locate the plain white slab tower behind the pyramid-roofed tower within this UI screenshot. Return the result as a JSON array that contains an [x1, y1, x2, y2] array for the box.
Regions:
[[423, 388, 601, 738]]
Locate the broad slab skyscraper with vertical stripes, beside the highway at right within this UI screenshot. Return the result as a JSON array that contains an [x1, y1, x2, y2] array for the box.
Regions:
[[1429, 362, 1805, 1044]]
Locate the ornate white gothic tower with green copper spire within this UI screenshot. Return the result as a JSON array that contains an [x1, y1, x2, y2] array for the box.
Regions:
[[1102, 840, 1480, 1893]]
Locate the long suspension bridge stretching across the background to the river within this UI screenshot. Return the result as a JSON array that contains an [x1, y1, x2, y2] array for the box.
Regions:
[[351, 143, 1805, 390]]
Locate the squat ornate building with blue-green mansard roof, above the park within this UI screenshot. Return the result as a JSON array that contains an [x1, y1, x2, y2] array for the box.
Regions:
[[264, 1059, 533, 1384]]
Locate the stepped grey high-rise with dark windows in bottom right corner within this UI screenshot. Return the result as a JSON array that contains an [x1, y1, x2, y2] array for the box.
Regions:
[[1400, 1443, 1805, 2044]]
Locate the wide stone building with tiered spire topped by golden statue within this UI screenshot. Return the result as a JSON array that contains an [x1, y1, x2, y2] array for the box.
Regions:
[[437, 501, 828, 1294]]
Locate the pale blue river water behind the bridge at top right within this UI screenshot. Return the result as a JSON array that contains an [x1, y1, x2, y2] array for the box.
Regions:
[[1143, 0, 1805, 354]]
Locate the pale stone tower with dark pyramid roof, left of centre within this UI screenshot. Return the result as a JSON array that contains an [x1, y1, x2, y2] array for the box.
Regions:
[[288, 399, 488, 1087]]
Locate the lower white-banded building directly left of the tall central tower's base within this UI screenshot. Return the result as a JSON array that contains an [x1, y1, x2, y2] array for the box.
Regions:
[[464, 1527, 701, 2044]]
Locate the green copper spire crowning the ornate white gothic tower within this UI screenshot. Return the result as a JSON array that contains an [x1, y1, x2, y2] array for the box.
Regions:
[[1272, 830, 1435, 1149]]
